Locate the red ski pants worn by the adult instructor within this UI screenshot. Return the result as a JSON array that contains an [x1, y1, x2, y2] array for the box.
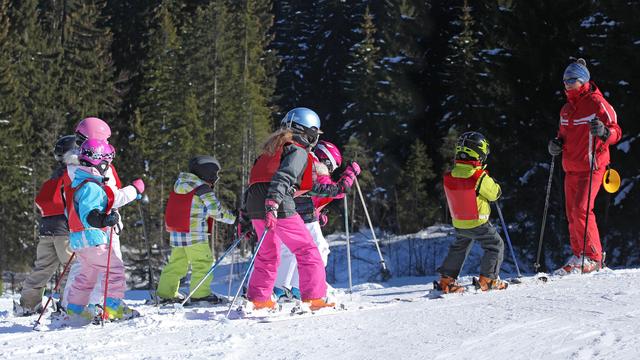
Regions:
[[564, 169, 605, 261]]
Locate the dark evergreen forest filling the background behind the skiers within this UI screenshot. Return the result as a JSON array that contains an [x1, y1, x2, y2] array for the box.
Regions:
[[0, 0, 640, 277]]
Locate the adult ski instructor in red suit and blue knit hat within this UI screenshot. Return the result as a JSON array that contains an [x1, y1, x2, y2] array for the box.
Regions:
[[549, 59, 622, 275]]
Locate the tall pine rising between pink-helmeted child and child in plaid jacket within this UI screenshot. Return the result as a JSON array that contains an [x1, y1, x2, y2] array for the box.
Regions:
[[127, 1, 188, 248]]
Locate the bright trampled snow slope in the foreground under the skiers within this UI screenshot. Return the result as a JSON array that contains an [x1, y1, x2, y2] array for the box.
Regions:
[[0, 269, 640, 360]]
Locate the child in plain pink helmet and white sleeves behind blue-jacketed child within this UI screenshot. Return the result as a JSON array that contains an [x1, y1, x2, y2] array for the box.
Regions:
[[62, 117, 145, 307]]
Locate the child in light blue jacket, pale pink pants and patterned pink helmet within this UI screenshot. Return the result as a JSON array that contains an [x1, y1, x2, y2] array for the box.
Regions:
[[66, 139, 137, 322]]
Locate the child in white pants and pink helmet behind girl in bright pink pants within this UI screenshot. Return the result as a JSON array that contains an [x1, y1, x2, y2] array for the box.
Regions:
[[273, 141, 360, 299]]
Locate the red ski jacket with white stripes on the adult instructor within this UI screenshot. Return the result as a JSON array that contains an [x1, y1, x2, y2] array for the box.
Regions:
[[558, 81, 622, 172]]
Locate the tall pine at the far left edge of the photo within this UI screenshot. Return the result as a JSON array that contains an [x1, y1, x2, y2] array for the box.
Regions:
[[0, 1, 66, 270]]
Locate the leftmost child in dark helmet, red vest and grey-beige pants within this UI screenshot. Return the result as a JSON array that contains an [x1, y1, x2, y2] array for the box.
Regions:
[[13, 135, 75, 316]]
